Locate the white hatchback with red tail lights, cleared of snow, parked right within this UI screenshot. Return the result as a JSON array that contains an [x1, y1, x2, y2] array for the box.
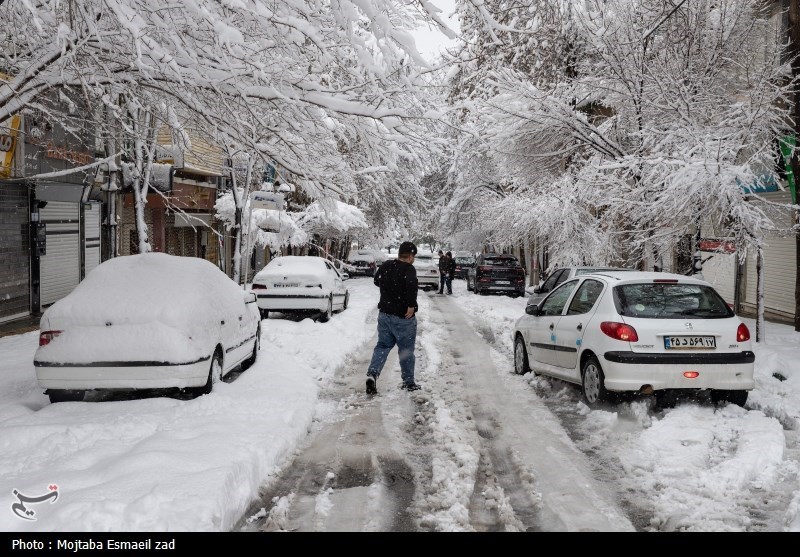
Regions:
[[513, 271, 755, 406]]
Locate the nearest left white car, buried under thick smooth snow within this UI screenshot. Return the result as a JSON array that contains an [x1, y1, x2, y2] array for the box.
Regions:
[[33, 253, 261, 402]]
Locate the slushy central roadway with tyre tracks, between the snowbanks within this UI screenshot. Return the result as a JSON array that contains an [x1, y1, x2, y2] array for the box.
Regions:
[[234, 286, 634, 531]]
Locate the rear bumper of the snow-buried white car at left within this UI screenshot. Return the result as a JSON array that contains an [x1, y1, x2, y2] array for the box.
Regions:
[[33, 356, 211, 390]]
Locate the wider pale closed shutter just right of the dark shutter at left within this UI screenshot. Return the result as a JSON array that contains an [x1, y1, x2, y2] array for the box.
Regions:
[[39, 201, 81, 306]]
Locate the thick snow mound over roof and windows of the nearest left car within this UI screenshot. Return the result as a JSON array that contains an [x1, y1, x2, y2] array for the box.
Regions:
[[42, 253, 243, 328]]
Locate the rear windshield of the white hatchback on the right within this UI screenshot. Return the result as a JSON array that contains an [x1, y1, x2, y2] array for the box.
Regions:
[[614, 283, 734, 319]]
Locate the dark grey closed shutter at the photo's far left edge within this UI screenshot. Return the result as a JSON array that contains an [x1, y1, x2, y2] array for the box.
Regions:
[[0, 183, 31, 322]]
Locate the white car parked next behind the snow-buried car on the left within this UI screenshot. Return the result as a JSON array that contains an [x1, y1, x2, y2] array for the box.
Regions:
[[251, 255, 350, 323]]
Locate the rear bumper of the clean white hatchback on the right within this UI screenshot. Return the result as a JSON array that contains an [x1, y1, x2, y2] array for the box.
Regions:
[[601, 351, 755, 391]]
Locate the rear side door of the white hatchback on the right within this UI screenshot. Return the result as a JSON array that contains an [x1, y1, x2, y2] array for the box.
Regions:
[[555, 279, 604, 374]]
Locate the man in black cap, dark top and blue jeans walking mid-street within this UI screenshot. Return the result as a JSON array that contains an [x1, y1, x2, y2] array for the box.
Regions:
[[367, 242, 420, 395]]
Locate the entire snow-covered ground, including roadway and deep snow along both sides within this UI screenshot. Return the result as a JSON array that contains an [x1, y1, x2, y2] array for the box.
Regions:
[[0, 279, 800, 532]]
